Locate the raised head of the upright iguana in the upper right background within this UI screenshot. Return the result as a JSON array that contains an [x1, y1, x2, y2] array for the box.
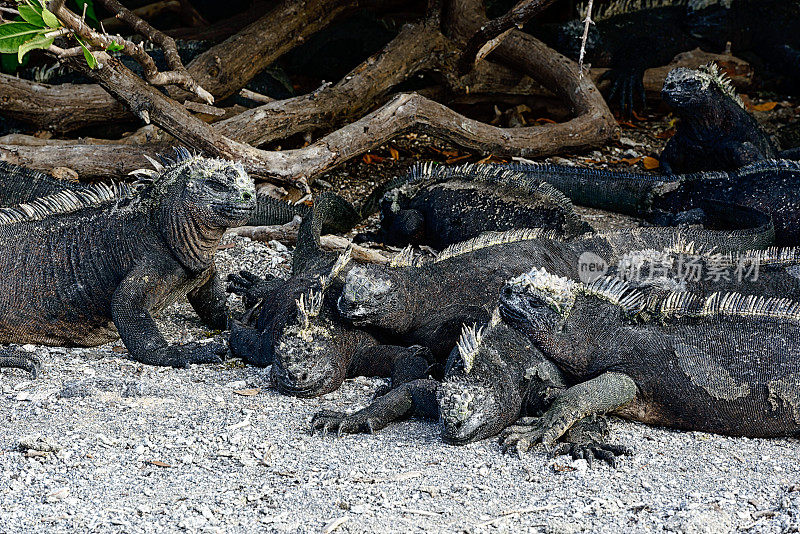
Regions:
[[661, 63, 744, 114]]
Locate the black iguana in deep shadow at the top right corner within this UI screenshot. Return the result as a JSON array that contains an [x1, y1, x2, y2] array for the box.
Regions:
[[539, 0, 800, 116]]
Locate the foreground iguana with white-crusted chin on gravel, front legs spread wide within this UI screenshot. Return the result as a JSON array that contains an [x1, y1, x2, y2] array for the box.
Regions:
[[311, 309, 629, 465]]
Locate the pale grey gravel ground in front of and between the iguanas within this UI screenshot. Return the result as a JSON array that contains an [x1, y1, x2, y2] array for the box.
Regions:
[[0, 238, 800, 533]]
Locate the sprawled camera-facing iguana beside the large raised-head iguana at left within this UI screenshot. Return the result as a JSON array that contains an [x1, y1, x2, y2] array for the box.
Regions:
[[229, 193, 432, 397]]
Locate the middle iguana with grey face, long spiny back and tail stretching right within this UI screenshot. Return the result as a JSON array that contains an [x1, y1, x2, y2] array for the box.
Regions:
[[338, 209, 773, 362]]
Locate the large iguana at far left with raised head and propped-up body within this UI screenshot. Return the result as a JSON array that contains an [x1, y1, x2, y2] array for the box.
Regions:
[[0, 149, 255, 378]]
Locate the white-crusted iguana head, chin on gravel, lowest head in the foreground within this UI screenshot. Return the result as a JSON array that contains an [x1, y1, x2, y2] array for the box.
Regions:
[[437, 314, 522, 445]]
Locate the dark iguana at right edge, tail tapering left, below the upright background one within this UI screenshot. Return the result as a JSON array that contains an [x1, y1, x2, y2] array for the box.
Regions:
[[512, 160, 800, 248]]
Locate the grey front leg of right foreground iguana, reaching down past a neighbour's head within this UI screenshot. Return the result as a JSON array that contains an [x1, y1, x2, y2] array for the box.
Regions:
[[500, 372, 637, 454]]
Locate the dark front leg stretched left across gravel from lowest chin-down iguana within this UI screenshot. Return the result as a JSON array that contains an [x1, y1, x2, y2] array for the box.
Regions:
[[311, 379, 439, 436]]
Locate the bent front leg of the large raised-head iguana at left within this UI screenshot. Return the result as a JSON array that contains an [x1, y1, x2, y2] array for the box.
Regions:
[[111, 265, 227, 367]]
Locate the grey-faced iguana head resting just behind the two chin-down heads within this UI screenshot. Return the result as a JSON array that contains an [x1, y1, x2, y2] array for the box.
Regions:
[[338, 265, 411, 331]]
